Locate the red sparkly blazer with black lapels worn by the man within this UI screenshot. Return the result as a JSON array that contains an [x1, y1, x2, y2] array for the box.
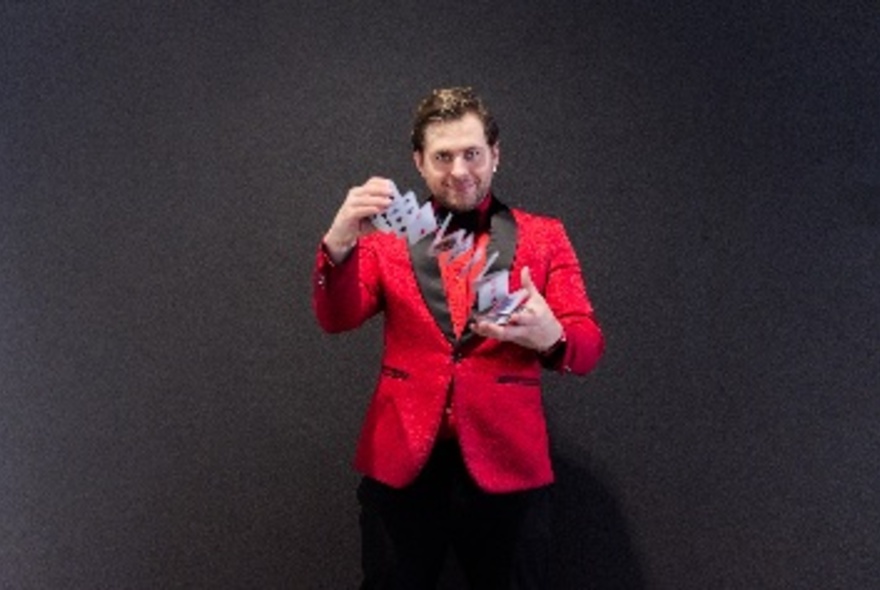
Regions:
[[313, 200, 604, 492]]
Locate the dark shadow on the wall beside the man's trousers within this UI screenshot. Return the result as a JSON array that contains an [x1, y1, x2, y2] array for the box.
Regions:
[[552, 453, 647, 590]]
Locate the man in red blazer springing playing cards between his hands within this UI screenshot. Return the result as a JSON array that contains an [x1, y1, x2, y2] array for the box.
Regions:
[[314, 88, 604, 590]]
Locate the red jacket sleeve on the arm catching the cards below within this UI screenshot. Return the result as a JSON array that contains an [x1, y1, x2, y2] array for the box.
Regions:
[[544, 221, 605, 375]]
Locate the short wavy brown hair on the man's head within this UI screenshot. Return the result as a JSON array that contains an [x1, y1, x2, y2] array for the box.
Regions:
[[410, 86, 498, 152]]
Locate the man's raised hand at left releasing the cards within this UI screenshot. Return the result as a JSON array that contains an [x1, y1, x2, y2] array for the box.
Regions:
[[324, 176, 394, 263]]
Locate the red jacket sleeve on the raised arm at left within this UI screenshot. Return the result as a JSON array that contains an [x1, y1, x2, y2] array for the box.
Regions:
[[312, 240, 382, 333]]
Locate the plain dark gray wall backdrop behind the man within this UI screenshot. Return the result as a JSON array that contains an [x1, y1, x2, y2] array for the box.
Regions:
[[0, 0, 880, 590]]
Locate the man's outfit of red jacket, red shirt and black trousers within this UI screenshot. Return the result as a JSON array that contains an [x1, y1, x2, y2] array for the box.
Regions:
[[314, 196, 604, 590]]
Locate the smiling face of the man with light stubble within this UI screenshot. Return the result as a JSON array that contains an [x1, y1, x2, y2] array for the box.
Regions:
[[413, 113, 499, 211]]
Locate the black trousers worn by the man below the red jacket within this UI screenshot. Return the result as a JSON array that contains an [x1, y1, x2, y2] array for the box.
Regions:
[[358, 441, 551, 590]]
